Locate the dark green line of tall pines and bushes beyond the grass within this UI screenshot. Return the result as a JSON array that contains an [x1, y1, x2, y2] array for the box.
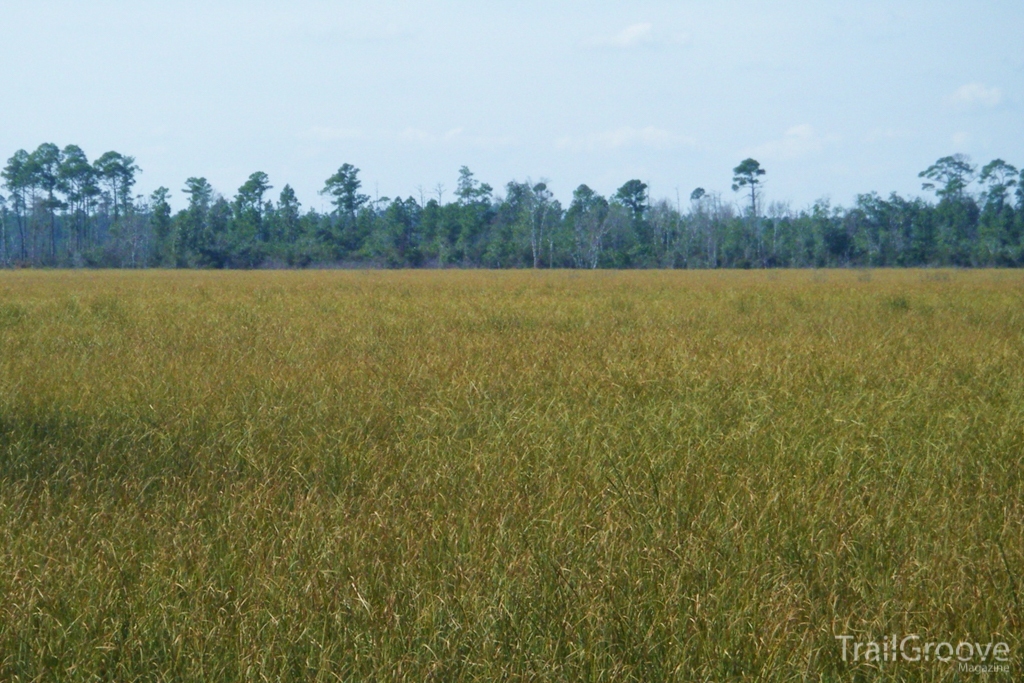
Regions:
[[0, 143, 1024, 268]]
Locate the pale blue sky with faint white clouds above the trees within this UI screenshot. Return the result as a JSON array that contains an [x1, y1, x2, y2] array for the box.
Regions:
[[0, 0, 1024, 209]]
